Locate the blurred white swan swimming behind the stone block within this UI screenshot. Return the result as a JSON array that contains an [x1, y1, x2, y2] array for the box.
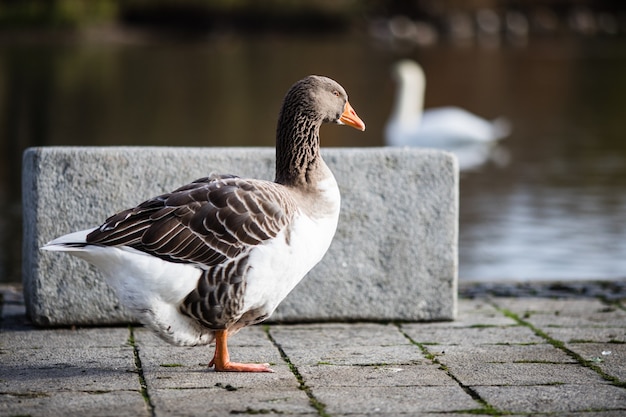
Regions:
[[385, 60, 511, 169]]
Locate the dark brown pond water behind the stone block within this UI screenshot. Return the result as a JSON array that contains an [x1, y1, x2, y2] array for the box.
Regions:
[[0, 31, 626, 282]]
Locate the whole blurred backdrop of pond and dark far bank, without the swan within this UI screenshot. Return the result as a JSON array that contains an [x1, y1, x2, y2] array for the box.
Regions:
[[0, 0, 626, 282]]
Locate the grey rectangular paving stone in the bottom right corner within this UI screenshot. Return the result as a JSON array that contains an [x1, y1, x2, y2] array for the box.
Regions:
[[473, 384, 626, 413]]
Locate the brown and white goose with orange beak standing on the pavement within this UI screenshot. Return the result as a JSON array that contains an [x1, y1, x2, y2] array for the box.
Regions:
[[42, 75, 365, 372]]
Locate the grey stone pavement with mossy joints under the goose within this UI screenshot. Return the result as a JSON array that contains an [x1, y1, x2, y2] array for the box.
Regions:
[[0, 285, 626, 417]]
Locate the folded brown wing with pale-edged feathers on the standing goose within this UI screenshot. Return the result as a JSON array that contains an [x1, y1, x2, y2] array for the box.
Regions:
[[87, 176, 296, 266]]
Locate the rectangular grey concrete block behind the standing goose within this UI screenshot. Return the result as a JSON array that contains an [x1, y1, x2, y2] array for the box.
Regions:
[[22, 147, 458, 326]]
